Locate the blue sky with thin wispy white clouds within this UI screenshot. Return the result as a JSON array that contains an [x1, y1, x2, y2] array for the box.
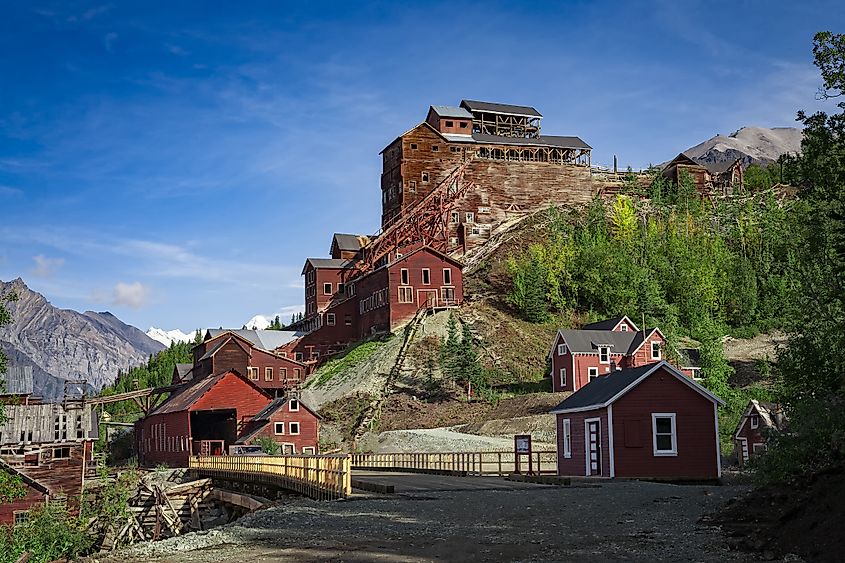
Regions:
[[0, 0, 845, 330]]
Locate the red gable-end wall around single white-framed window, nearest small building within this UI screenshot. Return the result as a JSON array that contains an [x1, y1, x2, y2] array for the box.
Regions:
[[613, 369, 719, 479]]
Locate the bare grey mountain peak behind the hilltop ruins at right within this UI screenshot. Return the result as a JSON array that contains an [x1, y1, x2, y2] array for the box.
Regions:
[[684, 127, 802, 170]]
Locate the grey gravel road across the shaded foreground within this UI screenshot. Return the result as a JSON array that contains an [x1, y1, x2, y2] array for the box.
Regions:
[[99, 478, 752, 563]]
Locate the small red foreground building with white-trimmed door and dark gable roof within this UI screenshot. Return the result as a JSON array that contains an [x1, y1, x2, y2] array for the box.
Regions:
[[551, 361, 724, 481]]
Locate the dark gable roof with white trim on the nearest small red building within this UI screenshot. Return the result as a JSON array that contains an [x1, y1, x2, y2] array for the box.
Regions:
[[551, 360, 725, 414]]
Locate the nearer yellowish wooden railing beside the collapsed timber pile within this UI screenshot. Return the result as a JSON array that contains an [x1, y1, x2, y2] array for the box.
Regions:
[[188, 455, 352, 500]]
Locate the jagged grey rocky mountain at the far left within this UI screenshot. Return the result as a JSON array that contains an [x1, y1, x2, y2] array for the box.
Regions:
[[0, 278, 164, 398]]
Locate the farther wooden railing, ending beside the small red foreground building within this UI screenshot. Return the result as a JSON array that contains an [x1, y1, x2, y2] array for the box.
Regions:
[[352, 450, 557, 475]]
